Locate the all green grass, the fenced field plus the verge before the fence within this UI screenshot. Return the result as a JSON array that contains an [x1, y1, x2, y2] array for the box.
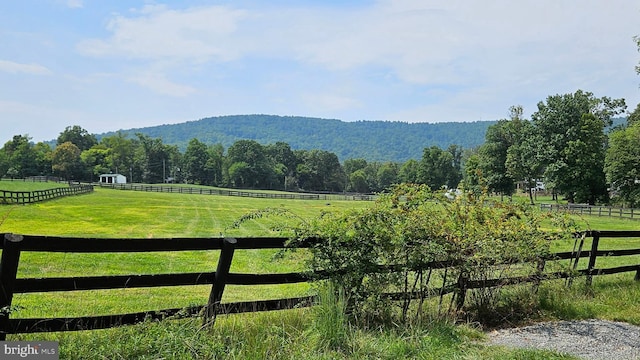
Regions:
[[0, 181, 640, 359]]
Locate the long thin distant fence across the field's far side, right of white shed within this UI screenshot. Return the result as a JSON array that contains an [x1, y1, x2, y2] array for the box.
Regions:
[[100, 183, 375, 201]]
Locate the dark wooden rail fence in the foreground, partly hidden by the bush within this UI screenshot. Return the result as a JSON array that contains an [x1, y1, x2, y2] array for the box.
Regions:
[[0, 231, 640, 340]]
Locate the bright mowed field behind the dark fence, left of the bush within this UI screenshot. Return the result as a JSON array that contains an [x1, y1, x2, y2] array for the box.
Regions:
[[0, 187, 371, 317]]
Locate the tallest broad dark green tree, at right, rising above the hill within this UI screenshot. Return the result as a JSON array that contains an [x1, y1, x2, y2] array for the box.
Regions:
[[532, 90, 626, 204]]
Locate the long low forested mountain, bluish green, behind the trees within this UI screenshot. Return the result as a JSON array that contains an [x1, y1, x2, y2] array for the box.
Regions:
[[98, 115, 495, 162]]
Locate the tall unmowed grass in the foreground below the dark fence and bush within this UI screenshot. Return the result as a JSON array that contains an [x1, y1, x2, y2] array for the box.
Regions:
[[10, 292, 570, 360]]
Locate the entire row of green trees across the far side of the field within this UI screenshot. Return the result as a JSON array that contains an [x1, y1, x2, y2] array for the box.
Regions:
[[0, 90, 640, 206]]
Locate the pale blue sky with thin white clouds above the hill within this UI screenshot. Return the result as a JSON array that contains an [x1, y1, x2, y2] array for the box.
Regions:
[[0, 0, 640, 143]]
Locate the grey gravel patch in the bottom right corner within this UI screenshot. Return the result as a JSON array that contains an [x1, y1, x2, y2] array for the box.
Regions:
[[487, 320, 640, 360]]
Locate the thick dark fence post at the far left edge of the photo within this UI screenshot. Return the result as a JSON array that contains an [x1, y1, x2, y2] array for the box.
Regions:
[[0, 234, 23, 341]]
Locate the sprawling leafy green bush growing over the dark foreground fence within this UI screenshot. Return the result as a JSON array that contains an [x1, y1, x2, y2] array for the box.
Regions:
[[290, 185, 575, 324]]
